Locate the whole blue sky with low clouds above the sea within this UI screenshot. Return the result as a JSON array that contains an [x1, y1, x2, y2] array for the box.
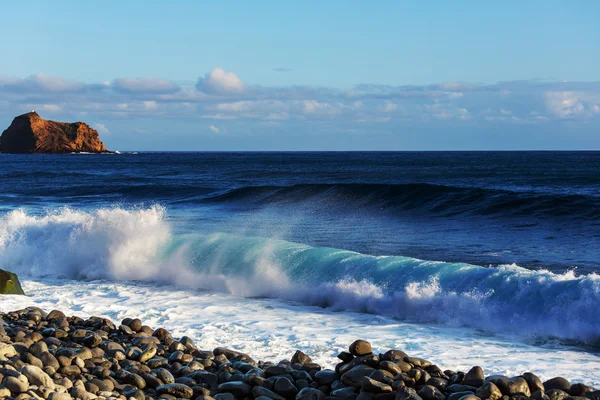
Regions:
[[0, 0, 600, 151]]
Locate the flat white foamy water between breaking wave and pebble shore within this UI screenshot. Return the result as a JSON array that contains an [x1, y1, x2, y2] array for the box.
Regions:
[[0, 280, 600, 385]]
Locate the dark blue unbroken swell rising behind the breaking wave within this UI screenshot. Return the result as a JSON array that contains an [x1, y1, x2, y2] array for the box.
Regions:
[[206, 183, 600, 220]]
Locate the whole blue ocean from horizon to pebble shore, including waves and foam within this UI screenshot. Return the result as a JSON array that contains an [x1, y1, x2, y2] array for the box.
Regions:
[[0, 152, 600, 385]]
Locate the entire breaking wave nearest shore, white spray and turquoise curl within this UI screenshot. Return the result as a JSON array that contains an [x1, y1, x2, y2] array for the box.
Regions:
[[0, 206, 600, 345]]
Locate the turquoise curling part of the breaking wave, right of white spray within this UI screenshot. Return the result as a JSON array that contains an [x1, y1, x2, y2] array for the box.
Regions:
[[175, 233, 600, 345]]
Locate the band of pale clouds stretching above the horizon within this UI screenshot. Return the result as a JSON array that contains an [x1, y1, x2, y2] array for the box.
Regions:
[[0, 67, 600, 150]]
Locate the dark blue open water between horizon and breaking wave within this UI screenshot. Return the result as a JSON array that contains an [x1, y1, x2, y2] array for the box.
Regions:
[[0, 152, 600, 274]]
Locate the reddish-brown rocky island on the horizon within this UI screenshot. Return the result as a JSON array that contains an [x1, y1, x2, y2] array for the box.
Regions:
[[0, 111, 107, 154]]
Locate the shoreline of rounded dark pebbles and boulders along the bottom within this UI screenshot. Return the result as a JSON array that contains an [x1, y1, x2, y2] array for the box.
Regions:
[[0, 307, 600, 400]]
